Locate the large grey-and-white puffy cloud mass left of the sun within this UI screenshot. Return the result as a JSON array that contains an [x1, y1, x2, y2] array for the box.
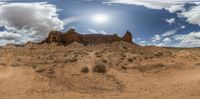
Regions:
[[0, 2, 63, 43]]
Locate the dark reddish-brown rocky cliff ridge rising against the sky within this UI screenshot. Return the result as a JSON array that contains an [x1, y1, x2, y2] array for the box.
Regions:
[[41, 29, 133, 45]]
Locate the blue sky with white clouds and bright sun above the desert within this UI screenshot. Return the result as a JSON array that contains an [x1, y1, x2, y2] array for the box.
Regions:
[[0, 0, 200, 47]]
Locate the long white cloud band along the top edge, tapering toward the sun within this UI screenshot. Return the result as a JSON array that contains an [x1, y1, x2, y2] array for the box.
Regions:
[[104, 0, 200, 26]]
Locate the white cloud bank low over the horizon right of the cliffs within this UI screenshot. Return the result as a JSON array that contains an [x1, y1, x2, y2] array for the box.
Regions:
[[151, 30, 200, 47]]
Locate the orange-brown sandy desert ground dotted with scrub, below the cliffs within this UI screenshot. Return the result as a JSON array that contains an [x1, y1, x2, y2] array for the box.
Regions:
[[0, 42, 200, 99]]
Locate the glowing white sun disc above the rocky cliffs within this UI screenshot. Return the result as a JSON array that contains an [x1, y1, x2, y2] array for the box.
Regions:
[[92, 14, 109, 24]]
